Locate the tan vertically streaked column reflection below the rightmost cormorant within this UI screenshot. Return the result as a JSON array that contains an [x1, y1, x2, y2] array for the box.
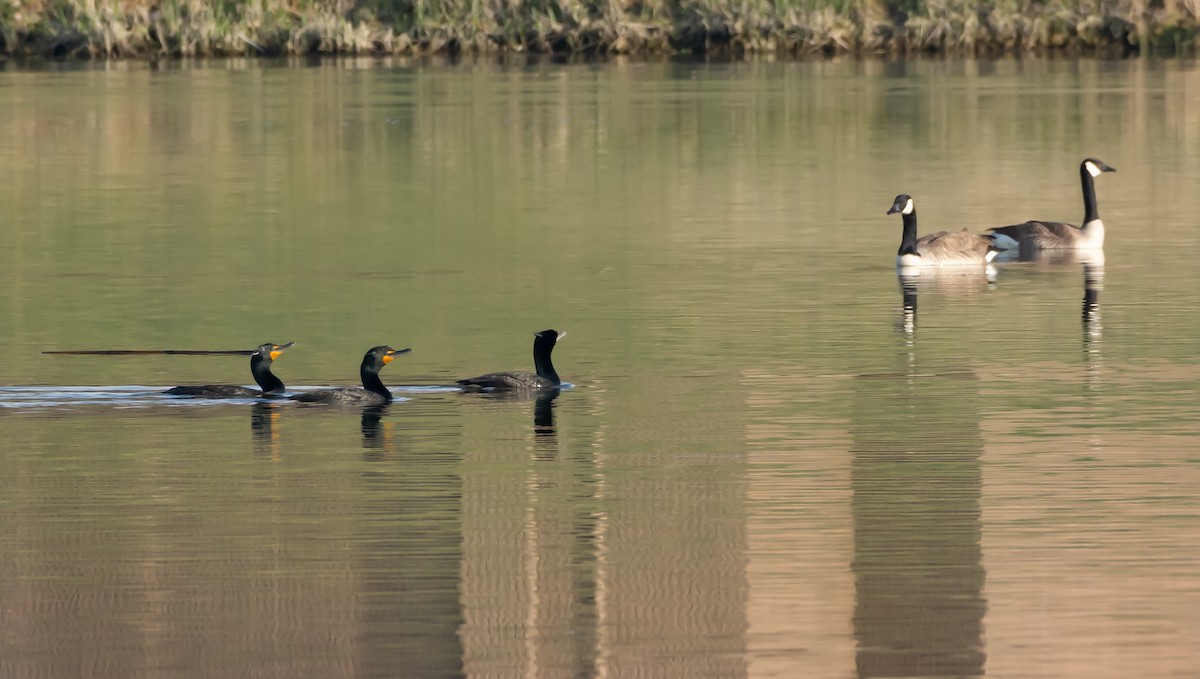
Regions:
[[453, 390, 628, 677]]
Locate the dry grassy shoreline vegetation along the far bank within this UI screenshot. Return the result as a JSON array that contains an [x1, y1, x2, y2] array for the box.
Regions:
[[0, 0, 1200, 59]]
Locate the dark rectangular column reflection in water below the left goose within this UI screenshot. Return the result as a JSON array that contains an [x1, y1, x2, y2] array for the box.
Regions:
[[851, 355, 986, 677]]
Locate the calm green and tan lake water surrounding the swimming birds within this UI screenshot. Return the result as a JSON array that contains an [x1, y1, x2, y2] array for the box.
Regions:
[[0, 59, 1200, 679]]
